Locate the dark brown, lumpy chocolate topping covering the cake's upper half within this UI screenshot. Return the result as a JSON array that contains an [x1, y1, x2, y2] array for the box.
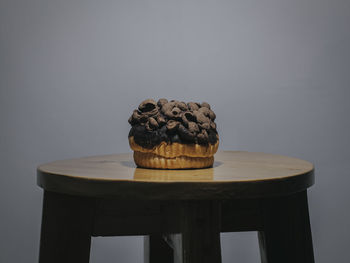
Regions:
[[128, 99, 218, 148]]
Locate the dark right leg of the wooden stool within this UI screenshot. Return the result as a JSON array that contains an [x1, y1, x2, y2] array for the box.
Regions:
[[258, 191, 314, 263]]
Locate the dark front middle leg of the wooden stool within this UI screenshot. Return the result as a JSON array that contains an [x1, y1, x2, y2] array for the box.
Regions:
[[181, 201, 221, 263]]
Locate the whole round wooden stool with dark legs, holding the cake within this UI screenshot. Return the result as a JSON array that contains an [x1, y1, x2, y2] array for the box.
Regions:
[[37, 151, 314, 263]]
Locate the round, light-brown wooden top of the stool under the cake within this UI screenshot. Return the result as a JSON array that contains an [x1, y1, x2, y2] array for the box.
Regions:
[[37, 151, 314, 200]]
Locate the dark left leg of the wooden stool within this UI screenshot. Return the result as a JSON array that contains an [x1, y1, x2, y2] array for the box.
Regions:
[[39, 191, 94, 263]]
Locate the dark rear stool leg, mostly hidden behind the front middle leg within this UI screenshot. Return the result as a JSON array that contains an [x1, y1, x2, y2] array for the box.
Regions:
[[144, 235, 174, 263]]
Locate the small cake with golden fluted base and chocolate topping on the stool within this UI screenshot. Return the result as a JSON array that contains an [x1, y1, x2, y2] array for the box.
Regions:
[[128, 99, 219, 169]]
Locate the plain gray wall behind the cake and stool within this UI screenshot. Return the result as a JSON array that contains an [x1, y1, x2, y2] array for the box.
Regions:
[[0, 0, 350, 263]]
